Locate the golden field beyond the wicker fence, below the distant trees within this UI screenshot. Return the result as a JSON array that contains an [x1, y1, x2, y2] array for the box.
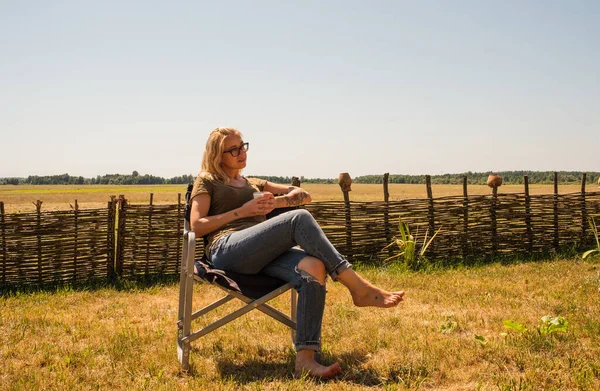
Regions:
[[0, 184, 596, 213]]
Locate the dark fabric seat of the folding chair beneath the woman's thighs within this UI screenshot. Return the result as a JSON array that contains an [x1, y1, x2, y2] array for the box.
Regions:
[[194, 256, 286, 299]]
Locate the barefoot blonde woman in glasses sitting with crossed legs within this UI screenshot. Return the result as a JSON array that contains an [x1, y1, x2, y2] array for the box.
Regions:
[[190, 128, 404, 378]]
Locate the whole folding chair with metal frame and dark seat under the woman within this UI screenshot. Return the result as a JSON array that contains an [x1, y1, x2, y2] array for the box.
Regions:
[[177, 184, 297, 370]]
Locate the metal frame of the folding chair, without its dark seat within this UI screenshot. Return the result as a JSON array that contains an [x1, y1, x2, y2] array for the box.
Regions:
[[177, 185, 297, 370]]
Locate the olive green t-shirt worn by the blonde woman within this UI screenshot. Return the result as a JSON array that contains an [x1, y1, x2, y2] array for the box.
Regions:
[[190, 175, 267, 251]]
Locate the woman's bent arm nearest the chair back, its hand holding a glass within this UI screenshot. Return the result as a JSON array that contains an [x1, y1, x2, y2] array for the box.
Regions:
[[190, 193, 275, 237]]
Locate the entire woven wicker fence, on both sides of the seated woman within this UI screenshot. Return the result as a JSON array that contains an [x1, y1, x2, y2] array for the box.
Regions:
[[0, 192, 600, 286]]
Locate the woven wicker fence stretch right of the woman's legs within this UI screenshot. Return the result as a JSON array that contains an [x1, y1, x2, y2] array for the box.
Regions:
[[306, 192, 600, 262]]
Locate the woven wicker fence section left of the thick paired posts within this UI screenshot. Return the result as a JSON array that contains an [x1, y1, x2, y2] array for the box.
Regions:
[[0, 201, 114, 285]]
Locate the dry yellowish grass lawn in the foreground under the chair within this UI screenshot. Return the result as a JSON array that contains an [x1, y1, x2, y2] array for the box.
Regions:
[[0, 260, 600, 390]]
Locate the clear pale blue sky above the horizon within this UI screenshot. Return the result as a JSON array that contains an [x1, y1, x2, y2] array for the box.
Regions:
[[0, 0, 600, 178]]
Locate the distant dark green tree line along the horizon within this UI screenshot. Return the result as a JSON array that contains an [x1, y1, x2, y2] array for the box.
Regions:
[[0, 171, 600, 185]]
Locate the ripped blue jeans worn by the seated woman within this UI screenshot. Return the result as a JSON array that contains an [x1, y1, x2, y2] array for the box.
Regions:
[[209, 209, 351, 350]]
